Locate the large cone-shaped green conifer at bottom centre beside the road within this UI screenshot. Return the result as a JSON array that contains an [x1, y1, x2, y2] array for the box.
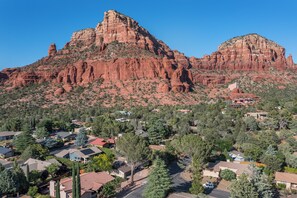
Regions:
[[143, 158, 171, 198]]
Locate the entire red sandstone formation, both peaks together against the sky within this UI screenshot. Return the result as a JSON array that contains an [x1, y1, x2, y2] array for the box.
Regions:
[[0, 10, 295, 95]]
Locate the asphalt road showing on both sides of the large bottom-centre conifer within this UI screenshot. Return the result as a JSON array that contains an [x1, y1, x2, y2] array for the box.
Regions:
[[118, 162, 190, 198]]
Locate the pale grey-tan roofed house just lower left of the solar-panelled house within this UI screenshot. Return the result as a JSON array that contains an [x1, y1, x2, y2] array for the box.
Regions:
[[21, 158, 62, 172]]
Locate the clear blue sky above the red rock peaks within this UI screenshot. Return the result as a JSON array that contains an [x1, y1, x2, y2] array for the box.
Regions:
[[0, 0, 297, 70]]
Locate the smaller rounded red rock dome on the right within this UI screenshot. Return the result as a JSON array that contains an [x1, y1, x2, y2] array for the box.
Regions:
[[191, 34, 290, 71]]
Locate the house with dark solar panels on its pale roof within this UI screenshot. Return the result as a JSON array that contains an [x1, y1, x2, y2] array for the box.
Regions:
[[55, 146, 102, 163]]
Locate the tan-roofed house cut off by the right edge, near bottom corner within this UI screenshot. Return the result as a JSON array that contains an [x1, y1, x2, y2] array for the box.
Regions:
[[275, 172, 297, 190]]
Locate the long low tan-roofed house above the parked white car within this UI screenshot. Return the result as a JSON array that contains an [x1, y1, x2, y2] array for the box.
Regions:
[[203, 161, 252, 178]]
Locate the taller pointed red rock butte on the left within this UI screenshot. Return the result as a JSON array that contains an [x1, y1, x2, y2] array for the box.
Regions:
[[1, 11, 192, 92]]
